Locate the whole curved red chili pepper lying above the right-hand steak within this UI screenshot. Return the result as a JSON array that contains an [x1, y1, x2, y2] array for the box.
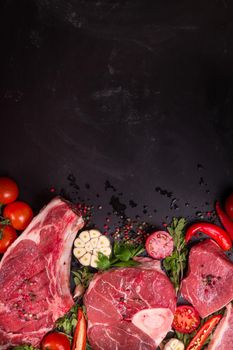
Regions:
[[185, 222, 232, 250]]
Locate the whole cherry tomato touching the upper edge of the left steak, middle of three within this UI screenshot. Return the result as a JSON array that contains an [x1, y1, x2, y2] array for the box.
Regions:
[[3, 201, 33, 231]]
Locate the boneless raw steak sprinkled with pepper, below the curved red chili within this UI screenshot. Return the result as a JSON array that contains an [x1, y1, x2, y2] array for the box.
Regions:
[[181, 240, 233, 318]]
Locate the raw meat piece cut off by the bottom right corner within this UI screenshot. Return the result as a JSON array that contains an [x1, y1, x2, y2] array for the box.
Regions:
[[207, 303, 233, 350]]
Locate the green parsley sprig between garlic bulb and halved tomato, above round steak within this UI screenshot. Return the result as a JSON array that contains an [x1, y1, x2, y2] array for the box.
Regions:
[[97, 242, 145, 270]]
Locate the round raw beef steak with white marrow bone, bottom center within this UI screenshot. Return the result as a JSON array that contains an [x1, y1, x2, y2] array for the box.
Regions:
[[84, 258, 176, 350]]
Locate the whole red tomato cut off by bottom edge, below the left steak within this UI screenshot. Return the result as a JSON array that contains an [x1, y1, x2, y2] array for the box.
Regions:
[[41, 332, 70, 350]]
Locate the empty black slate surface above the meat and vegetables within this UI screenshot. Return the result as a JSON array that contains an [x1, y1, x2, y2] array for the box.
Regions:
[[0, 0, 233, 232]]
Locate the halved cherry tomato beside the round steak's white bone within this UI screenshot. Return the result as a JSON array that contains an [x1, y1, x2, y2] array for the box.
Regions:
[[172, 305, 200, 333]]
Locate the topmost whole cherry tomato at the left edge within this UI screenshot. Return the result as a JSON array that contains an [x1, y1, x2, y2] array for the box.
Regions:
[[0, 177, 19, 204]]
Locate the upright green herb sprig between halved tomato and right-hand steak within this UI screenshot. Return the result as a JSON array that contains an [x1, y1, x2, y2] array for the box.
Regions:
[[163, 218, 188, 293]]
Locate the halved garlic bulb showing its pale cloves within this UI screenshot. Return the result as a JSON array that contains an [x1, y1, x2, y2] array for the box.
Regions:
[[73, 230, 112, 268]]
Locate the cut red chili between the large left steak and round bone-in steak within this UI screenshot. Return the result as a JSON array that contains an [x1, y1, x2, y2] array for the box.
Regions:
[[72, 309, 87, 350]]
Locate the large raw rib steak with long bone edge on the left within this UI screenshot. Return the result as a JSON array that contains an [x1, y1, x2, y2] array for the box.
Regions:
[[0, 197, 83, 349]]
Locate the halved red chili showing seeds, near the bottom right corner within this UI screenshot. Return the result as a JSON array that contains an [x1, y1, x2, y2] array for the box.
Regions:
[[186, 315, 222, 350]]
